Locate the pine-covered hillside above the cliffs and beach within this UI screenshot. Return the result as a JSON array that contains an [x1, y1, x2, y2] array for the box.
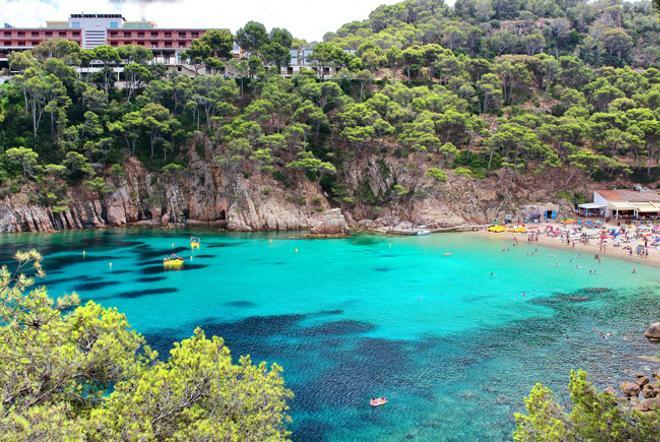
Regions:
[[0, 0, 660, 214]]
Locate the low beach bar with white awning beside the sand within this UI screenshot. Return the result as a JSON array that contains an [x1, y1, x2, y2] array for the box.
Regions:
[[578, 189, 660, 219]]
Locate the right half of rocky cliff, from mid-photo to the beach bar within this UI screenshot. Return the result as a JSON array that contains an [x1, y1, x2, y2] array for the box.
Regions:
[[343, 155, 593, 233]]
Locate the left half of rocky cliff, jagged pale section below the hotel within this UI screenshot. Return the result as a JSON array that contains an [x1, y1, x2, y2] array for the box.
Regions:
[[0, 148, 338, 232]]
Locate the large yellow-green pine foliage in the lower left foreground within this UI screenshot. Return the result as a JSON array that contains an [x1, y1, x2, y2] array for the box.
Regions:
[[0, 251, 292, 441]]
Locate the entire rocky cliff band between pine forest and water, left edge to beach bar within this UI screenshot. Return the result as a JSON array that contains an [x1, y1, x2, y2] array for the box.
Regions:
[[0, 142, 592, 235]]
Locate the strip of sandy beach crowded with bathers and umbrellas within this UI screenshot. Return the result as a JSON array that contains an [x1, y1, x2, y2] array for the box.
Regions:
[[469, 224, 660, 267]]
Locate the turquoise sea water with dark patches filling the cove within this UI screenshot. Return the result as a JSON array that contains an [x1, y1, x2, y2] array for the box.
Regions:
[[0, 230, 660, 441]]
